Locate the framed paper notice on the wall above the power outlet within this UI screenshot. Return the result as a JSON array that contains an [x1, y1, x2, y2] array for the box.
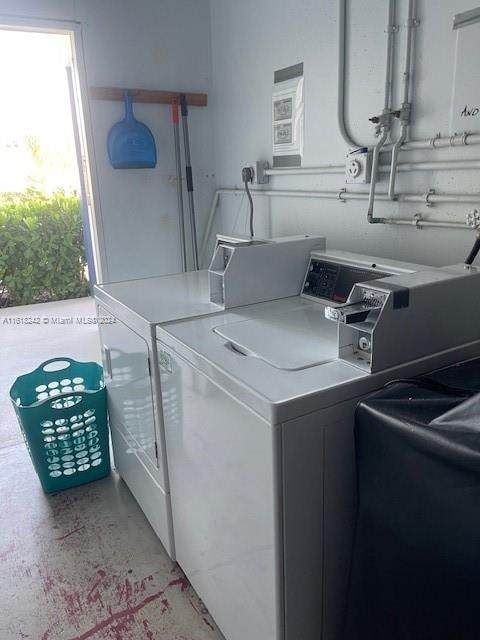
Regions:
[[272, 63, 304, 166]]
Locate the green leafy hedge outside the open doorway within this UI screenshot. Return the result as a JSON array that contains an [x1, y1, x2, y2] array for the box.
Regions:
[[0, 190, 89, 307]]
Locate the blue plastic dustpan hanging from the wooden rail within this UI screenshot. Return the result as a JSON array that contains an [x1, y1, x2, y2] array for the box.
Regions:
[[107, 91, 157, 169]]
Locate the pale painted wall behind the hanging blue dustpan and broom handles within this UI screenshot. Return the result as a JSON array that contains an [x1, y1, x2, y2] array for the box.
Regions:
[[0, 0, 214, 281]]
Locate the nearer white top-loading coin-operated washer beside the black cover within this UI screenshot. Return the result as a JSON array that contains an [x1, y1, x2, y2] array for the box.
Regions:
[[157, 252, 480, 640]]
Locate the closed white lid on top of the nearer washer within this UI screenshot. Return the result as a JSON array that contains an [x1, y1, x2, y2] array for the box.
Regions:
[[213, 304, 338, 371]]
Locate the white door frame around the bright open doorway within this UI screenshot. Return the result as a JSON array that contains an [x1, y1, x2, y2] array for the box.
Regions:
[[0, 14, 108, 282]]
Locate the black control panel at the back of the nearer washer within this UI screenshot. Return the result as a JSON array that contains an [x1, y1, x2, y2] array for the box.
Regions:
[[302, 258, 391, 303]]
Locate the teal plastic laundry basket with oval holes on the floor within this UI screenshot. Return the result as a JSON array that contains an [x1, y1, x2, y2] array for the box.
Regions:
[[10, 358, 110, 493]]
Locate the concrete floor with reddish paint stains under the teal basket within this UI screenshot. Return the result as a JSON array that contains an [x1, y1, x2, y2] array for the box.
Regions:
[[0, 298, 222, 640]]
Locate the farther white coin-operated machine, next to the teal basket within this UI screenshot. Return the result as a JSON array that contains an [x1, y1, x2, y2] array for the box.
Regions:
[[95, 236, 325, 559]]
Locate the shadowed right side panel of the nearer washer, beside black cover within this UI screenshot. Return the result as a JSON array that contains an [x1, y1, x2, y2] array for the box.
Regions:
[[282, 401, 356, 640]]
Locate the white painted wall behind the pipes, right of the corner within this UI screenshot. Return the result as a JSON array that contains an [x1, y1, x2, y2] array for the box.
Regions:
[[211, 0, 480, 264]]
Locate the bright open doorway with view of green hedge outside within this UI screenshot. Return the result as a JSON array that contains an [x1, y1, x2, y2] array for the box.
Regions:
[[0, 28, 95, 307]]
